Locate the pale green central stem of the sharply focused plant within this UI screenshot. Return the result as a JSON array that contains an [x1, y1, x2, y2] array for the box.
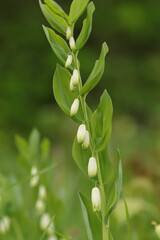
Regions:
[[74, 51, 109, 240]]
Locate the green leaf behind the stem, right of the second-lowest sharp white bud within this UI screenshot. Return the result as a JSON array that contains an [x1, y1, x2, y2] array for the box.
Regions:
[[98, 146, 113, 184]]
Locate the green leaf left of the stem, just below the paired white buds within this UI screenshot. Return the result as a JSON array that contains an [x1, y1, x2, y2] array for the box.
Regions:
[[72, 137, 92, 177]]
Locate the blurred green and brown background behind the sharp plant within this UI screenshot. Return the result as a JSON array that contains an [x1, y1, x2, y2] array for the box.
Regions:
[[0, 0, 160, 240]]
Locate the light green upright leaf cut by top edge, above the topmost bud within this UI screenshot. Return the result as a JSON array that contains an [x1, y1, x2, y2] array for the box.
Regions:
[[69, 0, 89, 23]]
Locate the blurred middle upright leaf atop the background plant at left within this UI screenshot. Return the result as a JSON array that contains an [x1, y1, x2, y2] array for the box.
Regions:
[[29, 129, 40, 159]]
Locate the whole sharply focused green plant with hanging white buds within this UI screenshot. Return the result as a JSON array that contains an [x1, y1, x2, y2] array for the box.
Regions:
[[39, 0, 122, 240]]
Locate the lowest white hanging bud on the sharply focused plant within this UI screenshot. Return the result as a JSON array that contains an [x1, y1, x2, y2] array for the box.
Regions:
[[91, 187, 101, 212]]
